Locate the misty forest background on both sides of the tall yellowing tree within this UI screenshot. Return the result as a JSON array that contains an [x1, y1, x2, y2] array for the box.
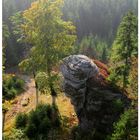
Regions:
[[3, 0, 138, 67]]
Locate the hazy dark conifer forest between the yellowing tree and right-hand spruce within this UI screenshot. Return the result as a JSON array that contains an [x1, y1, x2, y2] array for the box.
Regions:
[[63, 0, 138, 43]]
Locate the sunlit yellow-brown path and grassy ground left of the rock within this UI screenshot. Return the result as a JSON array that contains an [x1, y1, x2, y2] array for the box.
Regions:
[[4, 75, 78, 137]]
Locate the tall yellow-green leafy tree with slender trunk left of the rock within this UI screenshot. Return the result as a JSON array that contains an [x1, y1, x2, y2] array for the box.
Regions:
[[19, 0, 76, 104]]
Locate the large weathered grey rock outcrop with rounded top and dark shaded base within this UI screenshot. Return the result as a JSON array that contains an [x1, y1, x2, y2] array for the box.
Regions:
[[61, 55, 129, 137]]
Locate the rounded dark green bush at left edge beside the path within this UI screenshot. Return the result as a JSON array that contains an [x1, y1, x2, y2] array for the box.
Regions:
[[2, 74, 24, 100]]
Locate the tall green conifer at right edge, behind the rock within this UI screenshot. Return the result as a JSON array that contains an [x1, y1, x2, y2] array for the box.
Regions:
[[111, 11, 138, 88]]
